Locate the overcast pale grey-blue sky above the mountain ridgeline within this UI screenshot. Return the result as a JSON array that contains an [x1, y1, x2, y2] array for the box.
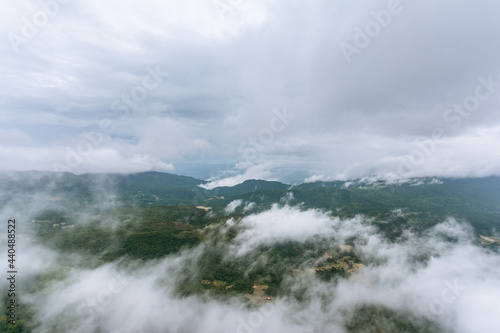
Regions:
[[0, 0, 500, 187]]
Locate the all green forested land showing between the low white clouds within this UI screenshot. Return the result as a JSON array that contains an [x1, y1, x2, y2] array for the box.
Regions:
[[0, 173, 500, 332]]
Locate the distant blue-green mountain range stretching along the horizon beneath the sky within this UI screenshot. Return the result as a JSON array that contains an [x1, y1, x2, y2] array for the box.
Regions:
[[0, 171, 500, 234]]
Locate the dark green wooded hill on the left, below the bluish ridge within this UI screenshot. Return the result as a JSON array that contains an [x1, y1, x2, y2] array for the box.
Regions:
[[33, 206, 215, 263]]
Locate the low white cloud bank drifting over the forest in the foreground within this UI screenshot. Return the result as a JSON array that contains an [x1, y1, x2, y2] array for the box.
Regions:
[[0, 196, 500, 333]]
